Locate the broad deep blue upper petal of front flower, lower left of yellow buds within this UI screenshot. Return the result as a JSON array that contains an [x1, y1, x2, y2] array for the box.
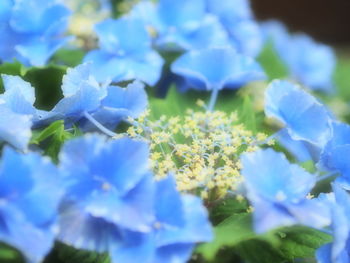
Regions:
[[60, 135, 149, 196]]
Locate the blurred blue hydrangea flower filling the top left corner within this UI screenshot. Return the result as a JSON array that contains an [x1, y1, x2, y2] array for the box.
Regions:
[[0, 0, 70, 66]]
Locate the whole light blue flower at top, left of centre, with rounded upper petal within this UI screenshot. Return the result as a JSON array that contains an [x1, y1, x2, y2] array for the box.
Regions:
[[84, 17, 164, 86]]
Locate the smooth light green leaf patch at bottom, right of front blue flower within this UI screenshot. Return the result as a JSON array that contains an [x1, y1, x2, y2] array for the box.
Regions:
[[197, 213, 256, 260]]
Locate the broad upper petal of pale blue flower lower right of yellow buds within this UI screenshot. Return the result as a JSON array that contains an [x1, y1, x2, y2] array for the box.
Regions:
[[241, 149, 315, 203]]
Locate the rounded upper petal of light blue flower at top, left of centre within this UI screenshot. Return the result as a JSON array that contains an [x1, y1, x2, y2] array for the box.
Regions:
[[96, 17, 151, 56]]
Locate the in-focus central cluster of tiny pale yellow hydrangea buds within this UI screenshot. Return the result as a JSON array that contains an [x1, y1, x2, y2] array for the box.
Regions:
[[128, 107, 273, 200]]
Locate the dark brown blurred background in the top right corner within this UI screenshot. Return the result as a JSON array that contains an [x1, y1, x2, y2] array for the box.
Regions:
[[251, 0, 350, 46]]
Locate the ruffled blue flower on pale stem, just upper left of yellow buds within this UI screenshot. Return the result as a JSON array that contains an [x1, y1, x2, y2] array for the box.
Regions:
[[41, 64, 147, 132]]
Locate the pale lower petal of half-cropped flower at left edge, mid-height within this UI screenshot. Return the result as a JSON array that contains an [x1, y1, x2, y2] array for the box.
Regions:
[[0, 104, 32, 150]]
